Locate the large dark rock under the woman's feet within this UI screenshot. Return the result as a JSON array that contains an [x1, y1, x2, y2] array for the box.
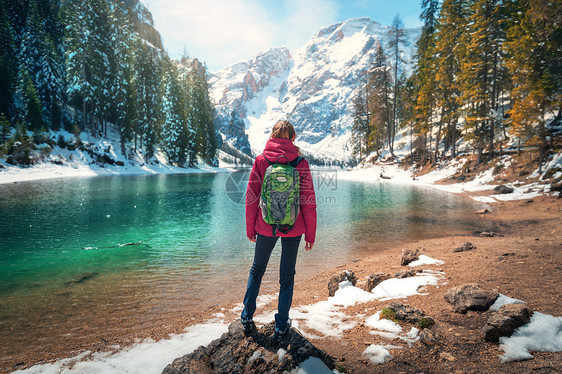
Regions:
[[162, 320, 335, 374]]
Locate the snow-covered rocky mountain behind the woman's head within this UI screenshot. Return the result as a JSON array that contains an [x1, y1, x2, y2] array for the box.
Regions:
[[210, 18, 419, 159]]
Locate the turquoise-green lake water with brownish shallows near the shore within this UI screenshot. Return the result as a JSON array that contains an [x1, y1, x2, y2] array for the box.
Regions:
[[0, 171, 483, 362]]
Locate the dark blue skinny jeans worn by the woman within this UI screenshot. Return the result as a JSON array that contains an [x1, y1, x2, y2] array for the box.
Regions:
[[242, 234, 302, 330]]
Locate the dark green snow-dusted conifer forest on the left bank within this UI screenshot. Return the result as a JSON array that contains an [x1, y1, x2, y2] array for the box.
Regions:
[[0, 0, 217, 166]]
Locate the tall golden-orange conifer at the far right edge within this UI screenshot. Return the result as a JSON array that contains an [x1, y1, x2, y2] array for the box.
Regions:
[[505, 0, 562, 171]]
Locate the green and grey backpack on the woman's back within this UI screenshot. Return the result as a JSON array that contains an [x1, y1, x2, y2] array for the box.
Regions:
[[260, 155, 304, 236]]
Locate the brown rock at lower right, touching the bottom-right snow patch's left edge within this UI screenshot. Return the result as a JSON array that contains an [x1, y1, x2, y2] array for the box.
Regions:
[[482, 304, 533, 343]]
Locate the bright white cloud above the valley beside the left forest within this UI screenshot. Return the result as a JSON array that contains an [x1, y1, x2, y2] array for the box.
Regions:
[[145, 0, 274, 66]]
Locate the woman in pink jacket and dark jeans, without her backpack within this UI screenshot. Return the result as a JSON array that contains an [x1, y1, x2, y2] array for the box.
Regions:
[[241, 121, 316, 340]]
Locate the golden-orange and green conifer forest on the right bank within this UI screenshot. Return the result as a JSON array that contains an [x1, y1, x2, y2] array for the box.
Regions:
[[352, 0, 562, 165]]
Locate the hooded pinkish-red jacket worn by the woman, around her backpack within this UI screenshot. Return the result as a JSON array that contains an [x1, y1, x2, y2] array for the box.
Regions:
[[246, 138, 316, 243]]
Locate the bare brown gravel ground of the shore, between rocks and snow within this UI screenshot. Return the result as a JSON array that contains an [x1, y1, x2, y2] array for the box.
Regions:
[[4, 191, 562, 373]]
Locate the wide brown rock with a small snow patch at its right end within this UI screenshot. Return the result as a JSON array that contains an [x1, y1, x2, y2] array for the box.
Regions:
[[444, 283, 499, 313]]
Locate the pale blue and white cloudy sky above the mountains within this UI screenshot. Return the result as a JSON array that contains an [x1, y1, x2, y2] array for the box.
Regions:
[[141, 0, 421, 72]]
